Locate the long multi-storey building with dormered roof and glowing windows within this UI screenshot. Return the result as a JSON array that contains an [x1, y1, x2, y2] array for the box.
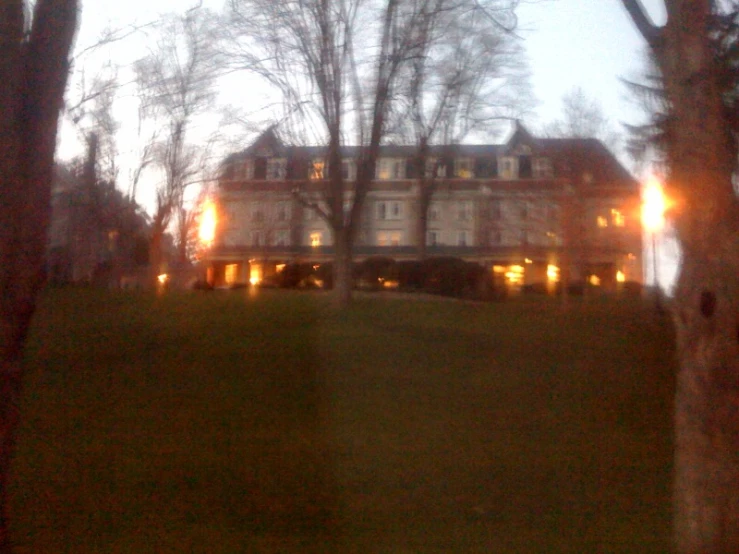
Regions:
[[207, 124, 642, 288]]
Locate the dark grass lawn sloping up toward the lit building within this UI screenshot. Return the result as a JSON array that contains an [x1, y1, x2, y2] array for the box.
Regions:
[[11, 290, 675, 554]]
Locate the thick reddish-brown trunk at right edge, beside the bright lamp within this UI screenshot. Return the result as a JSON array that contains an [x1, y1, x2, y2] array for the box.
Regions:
[[622, 0, 739, 554]]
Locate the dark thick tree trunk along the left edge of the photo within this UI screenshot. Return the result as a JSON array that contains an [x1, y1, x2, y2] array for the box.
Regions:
[[0, 0, 77, 553]]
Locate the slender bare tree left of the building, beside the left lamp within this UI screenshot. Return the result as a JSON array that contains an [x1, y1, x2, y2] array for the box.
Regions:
[[135, 7, 216, 281]]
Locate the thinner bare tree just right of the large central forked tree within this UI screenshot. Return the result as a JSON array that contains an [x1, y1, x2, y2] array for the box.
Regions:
[[390, 0, 530, 259]]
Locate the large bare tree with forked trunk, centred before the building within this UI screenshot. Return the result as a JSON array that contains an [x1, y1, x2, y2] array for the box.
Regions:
[[228, 0, 440, 306]]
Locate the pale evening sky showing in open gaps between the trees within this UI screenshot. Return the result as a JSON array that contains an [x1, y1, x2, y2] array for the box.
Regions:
[[66, 0, 674, 286]]
